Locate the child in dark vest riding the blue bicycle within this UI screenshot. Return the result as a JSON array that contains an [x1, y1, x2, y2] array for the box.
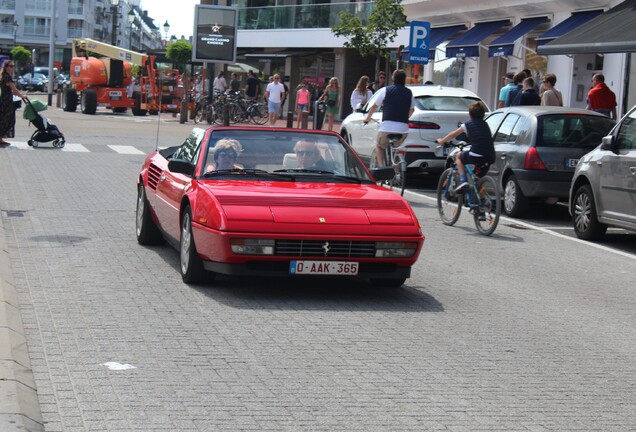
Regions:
[[436, 102, 495, 192]]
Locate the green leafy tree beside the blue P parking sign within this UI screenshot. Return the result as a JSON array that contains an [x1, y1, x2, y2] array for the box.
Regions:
[[331, 0, 408, 72]]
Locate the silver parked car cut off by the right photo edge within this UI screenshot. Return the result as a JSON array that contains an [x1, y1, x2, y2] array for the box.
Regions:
[[569, 106, 636, 240]]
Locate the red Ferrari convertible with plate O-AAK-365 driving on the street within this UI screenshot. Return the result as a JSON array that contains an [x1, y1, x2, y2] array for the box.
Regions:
[[136, 127, 424, 286]]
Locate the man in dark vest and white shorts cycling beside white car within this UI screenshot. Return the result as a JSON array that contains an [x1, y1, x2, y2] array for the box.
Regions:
[[363, 69, 414, 167]]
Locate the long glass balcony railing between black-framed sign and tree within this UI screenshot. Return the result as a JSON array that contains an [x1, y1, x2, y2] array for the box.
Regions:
[[238, 1, 375, 30]]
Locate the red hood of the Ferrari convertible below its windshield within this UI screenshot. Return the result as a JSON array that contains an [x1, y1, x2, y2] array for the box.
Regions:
[[195, 181, 420, 236]]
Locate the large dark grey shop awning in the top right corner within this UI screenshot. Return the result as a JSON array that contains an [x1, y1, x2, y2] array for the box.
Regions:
[[537, 0, 636, 55]]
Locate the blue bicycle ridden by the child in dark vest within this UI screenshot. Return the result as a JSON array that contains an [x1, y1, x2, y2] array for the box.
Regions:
[[437, 142, 501, 236]]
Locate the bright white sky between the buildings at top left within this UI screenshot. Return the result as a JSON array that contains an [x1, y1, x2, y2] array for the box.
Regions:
[[141, 0, 200, 39]]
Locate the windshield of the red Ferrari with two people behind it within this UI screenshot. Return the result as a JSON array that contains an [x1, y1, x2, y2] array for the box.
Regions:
[[202, 129, 371, 181]]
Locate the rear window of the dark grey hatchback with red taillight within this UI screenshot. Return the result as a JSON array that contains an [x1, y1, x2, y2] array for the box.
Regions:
[[537, 114, 614, 149]]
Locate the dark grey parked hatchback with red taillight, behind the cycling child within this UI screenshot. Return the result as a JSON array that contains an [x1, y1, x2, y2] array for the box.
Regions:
[[486, 106, 615, 217]]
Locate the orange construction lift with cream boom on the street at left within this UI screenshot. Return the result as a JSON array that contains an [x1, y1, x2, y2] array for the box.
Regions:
[[63, 39, 194, 116]]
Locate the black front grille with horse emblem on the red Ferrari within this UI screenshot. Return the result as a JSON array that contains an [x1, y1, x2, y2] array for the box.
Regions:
[[274, 240, 375, 258]]
